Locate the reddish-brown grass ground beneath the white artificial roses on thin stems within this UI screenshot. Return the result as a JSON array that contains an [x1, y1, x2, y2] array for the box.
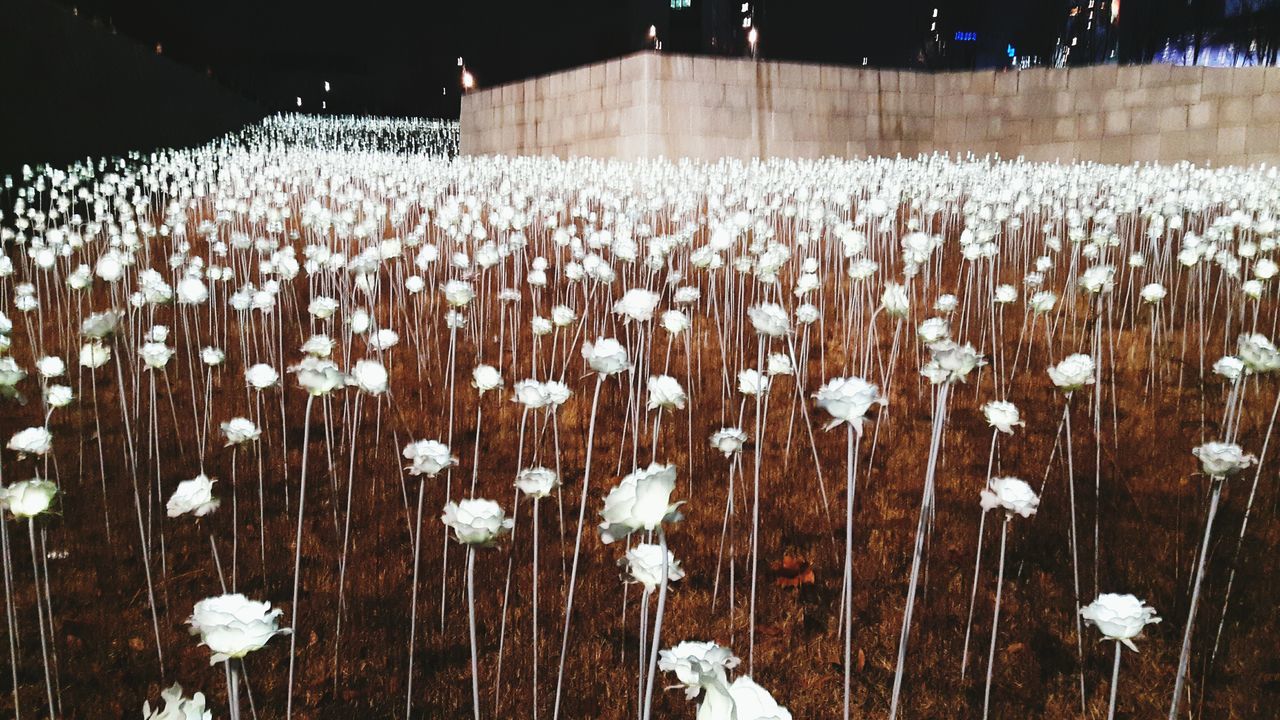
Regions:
[[0, 178, 1280, 719]]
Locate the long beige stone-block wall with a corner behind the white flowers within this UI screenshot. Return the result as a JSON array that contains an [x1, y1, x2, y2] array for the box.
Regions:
[[461, 53, 1280, 165]]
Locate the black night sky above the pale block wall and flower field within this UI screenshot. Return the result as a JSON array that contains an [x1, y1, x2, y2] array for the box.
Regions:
[[49, 0, 947, 117]]
